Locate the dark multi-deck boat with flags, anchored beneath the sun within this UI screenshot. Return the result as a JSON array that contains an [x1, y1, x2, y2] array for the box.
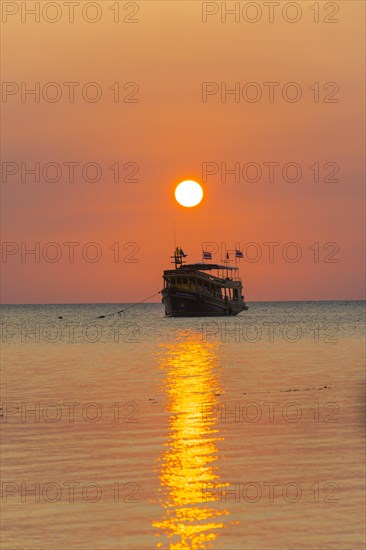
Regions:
[[161, 247, 248, 317]]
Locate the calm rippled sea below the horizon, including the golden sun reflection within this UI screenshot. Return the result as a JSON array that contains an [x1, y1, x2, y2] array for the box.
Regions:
[[0, 302, 365, 550]]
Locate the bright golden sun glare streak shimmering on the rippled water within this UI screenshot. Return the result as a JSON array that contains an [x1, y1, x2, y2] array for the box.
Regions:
[[153, 332, 229, 550]]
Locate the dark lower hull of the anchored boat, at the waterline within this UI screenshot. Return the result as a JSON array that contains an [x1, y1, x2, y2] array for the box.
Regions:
[[162, 288, 248, 317]]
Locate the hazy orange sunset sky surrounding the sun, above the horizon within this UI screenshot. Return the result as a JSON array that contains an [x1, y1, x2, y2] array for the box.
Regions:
[[1, 0, 365, 303]]
